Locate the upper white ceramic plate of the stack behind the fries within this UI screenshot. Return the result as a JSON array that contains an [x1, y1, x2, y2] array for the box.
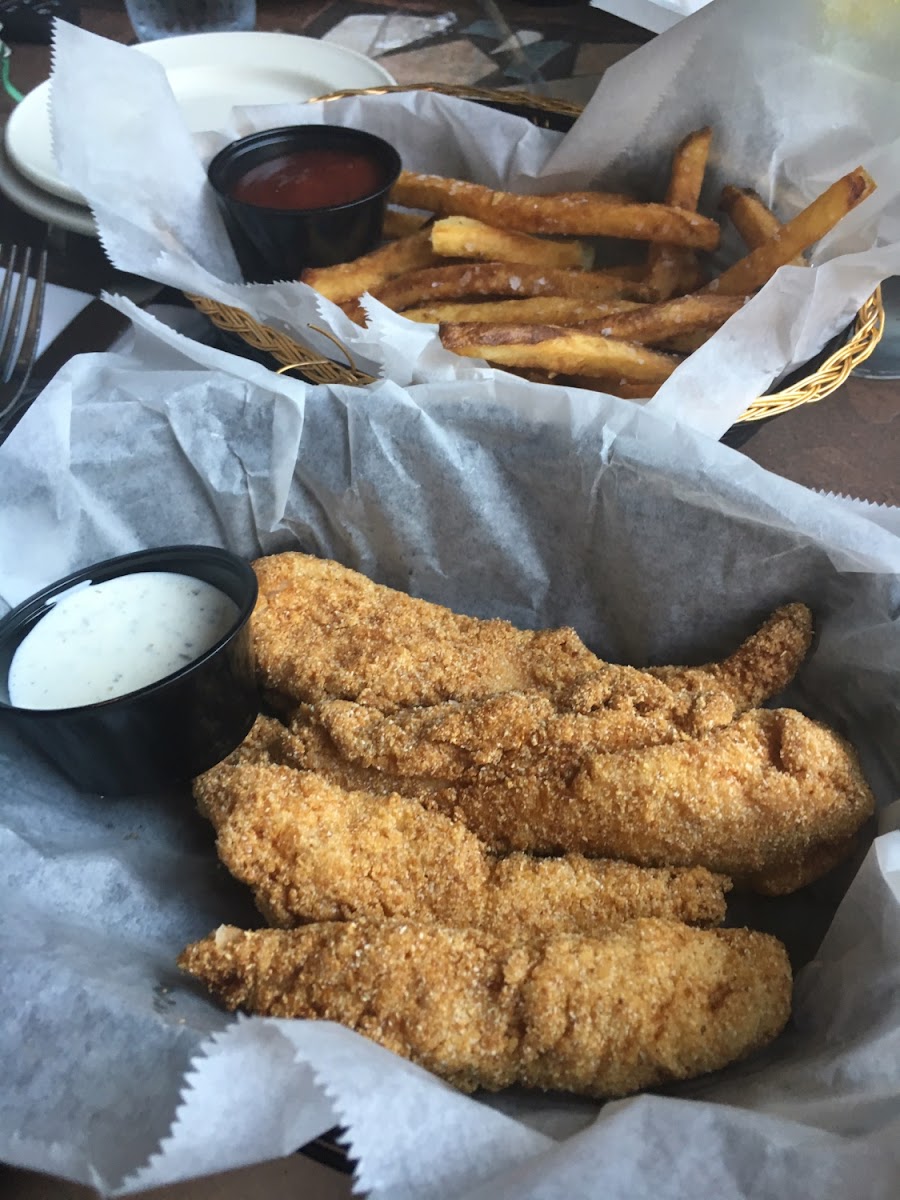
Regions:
[[6, 32, 395, 203]]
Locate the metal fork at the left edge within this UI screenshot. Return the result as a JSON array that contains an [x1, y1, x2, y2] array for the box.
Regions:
[[0, 244, 47, 425]]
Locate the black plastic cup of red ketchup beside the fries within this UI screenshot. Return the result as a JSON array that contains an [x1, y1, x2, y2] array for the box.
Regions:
[[206, 125, 401, 283]]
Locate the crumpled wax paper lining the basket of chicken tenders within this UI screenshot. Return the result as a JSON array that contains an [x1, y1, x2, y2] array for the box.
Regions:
[[0, 300, 900, 1200]]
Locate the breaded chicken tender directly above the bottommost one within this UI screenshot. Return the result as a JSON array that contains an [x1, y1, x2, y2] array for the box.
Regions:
[[194, 718, 731, 936]]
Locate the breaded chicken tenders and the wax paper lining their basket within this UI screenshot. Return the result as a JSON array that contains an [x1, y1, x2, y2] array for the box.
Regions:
[[0, 285, 900, 1200]]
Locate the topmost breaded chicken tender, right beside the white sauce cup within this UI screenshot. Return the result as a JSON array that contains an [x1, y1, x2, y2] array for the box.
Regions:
[[252, 553, 599, 712]]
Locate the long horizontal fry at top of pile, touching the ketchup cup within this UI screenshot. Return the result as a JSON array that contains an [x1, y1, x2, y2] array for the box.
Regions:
[[391, 170, 719, 250]]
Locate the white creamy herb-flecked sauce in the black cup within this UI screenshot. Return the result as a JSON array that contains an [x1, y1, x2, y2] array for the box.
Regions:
[[7, 571, 239, 708]]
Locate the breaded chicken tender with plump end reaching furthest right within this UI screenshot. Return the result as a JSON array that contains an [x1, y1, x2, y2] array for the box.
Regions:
[[236, 706, 874, 895]]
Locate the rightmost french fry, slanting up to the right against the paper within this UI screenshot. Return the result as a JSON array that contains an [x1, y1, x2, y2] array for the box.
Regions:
[[707, 167, 875, 295]]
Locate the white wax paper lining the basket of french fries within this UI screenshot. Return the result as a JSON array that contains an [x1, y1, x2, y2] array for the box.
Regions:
[[52, 0, 900, 437]]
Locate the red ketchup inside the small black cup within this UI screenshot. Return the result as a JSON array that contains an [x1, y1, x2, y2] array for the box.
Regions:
[[230, 149, 384, 209]]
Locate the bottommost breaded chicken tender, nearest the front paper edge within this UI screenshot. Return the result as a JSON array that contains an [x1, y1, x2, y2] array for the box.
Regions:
[[179, 919, 791, 1098]]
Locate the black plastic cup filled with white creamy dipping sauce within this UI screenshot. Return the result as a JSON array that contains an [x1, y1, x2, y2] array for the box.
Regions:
[[0, 546, 259, 796]]
